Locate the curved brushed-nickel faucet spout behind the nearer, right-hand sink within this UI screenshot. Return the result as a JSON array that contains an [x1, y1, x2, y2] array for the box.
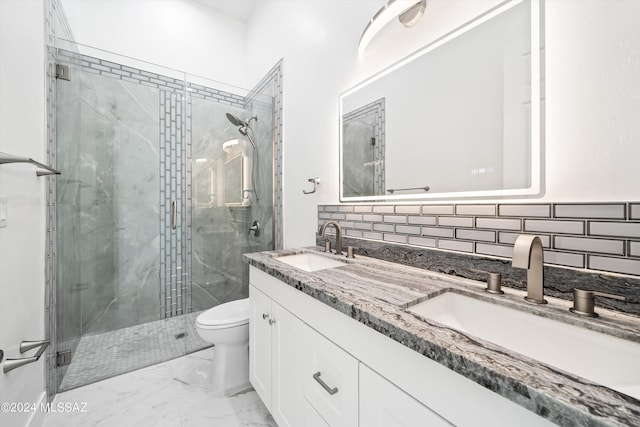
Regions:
[[511, 236, 547, 304]]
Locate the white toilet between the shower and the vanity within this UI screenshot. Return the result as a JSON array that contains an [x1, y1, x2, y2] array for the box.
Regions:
[[196, 298, 251, 396]]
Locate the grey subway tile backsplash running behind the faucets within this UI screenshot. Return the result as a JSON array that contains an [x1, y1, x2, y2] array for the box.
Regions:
[[318, 202, 640, 276]]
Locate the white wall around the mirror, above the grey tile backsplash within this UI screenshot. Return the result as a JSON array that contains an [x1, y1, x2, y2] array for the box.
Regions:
[[247, 0, 640, 247]]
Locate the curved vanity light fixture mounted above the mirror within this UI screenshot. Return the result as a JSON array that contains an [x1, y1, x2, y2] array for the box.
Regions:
[[358, 0, 427, 56]]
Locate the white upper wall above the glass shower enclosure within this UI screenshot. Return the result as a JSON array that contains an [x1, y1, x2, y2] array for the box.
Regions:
[[62, 0, 250, 87]]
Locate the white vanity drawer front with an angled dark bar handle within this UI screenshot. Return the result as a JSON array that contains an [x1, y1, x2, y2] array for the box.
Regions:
[[303, 330, 359, 427]]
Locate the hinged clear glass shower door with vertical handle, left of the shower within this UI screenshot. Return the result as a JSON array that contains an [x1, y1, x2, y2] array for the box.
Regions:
[[56, 47, 188, 391]]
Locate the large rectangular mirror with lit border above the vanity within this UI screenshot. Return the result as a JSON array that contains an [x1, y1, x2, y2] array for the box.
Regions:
[[340, 0, 544, 202]]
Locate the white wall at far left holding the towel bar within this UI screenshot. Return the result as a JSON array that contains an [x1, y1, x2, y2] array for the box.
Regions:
[[0, 0, 46, 427]]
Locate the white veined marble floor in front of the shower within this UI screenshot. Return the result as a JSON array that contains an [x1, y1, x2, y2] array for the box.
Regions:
[[43, 348, 276, 427]]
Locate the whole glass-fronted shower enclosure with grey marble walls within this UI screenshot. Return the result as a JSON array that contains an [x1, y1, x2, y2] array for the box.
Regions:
[[55, 44, 275, 391]]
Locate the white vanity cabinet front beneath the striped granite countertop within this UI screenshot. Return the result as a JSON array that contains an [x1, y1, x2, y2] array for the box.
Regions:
[[249, 267, 553, 427]]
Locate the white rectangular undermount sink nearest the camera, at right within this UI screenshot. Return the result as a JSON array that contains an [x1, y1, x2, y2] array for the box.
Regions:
[[407, 292, 640, 399]]
